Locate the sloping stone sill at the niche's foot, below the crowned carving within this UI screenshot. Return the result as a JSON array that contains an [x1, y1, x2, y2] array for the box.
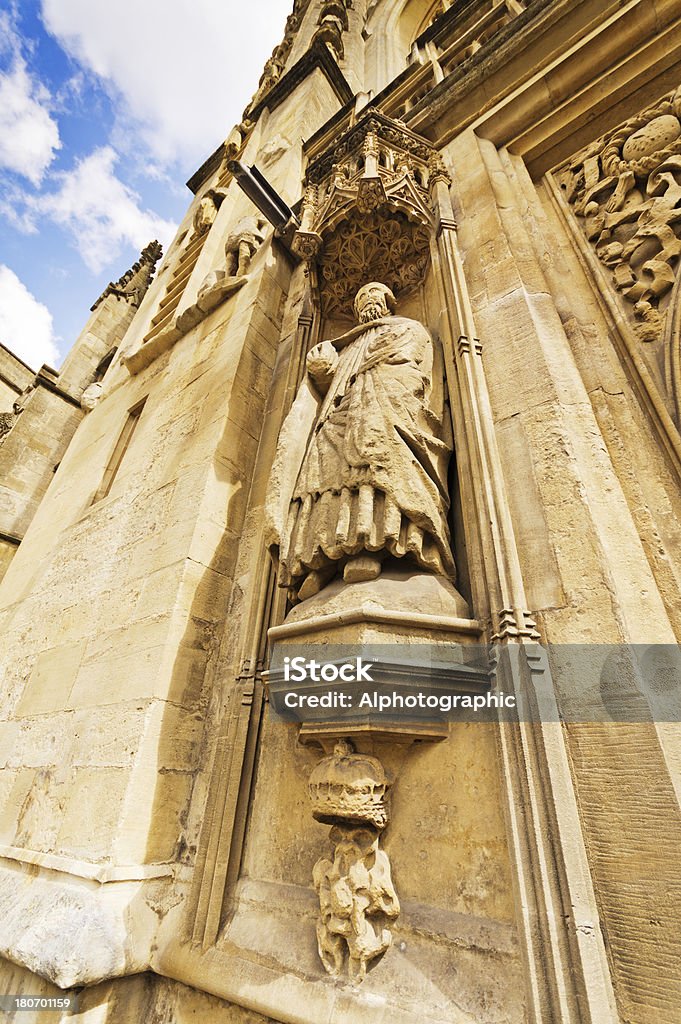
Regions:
[[152, 880, 518, 1024]]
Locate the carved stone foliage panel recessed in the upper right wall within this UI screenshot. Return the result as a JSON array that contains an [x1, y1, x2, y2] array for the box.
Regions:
[[558, 88, 681, 343]]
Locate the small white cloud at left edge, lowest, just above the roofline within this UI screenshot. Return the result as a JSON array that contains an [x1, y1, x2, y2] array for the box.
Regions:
[[0, 263, 59, 370]]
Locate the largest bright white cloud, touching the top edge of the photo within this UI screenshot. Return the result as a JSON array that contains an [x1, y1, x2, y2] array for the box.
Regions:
[[42, 0, 293, 165]]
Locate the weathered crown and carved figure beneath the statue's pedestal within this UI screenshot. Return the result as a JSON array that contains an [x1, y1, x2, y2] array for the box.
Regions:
[[309, 740, 399, 982]]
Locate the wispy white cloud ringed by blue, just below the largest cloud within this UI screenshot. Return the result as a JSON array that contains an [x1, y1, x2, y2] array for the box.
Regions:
[[36, 145, 176, 273]]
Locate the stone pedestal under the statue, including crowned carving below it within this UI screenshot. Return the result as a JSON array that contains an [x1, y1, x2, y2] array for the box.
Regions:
[[267, 563, 491, 983]]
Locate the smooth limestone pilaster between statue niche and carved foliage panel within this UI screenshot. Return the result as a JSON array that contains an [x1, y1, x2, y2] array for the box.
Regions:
[[449, 112, 681, 1022]]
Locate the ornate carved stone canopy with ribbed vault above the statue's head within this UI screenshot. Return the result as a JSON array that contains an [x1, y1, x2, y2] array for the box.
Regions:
[[292, 110, 446, 319]]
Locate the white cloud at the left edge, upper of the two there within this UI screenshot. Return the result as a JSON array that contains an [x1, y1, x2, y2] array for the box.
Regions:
[[0, 11, 61, 185]]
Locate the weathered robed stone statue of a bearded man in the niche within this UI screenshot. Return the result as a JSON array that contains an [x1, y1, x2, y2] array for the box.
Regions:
[[267, 282, 456, 601]]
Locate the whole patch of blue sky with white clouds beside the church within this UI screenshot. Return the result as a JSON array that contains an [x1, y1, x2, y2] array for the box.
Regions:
[[0, 0, 293, 370]]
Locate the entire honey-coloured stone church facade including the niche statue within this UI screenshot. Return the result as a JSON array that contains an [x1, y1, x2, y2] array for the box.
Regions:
[[0, 0, 681, 1024]]
